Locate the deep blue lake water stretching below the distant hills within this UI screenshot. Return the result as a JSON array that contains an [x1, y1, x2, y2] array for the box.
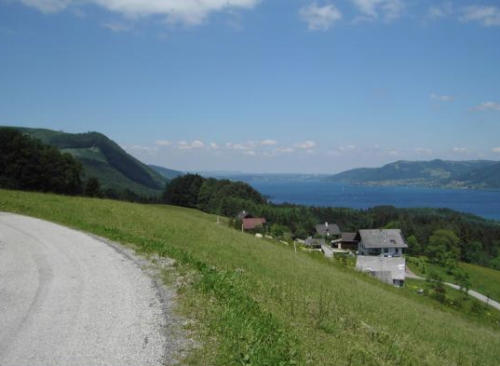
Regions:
[[248, 181, 500, 220]]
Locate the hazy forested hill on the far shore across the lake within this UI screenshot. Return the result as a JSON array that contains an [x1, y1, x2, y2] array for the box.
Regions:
[[326, 159, 500, 189]]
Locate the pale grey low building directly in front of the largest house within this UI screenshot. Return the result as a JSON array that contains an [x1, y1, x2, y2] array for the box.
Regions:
[[356, 255, 406, 287]]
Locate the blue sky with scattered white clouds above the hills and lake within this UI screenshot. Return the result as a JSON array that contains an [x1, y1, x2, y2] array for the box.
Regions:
[[0, 0, 500, 173]]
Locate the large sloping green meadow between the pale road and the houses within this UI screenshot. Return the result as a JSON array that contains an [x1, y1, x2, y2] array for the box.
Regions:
[[0, 190, 500, 365]]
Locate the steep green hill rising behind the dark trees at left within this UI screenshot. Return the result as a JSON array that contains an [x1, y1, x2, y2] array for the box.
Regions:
[[10, 127, 167, 196]]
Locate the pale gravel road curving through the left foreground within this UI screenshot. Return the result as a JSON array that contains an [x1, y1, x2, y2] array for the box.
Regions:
[[0, 213, 166, 366]]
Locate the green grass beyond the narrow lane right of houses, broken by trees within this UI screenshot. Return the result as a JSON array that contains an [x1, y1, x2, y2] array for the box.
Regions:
[[409, 262, 500, 301]]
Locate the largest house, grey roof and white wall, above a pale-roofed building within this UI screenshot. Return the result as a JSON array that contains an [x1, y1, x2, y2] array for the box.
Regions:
[[355, 229, 408, 257]]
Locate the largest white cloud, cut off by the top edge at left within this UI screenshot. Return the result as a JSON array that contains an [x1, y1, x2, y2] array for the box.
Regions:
[[21, 0, 260, 25]]
